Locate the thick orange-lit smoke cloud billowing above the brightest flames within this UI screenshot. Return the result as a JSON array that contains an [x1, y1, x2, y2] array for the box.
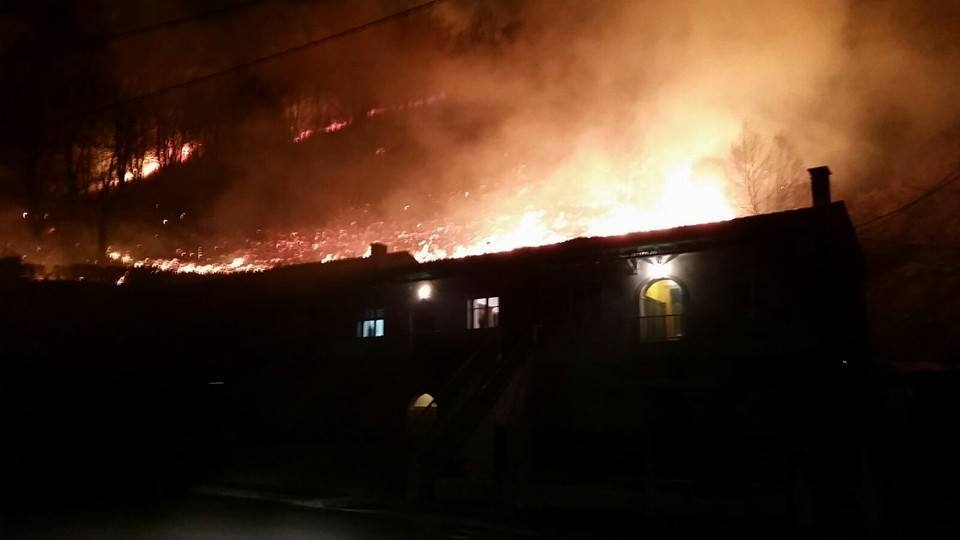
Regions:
[[214, 0, 960, 240]]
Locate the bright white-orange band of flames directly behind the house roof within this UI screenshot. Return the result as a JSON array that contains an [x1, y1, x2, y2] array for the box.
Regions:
[[109, 154, 735, 274]]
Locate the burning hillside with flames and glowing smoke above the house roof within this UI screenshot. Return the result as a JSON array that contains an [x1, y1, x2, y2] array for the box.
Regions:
[[0, 0, 960, 273]]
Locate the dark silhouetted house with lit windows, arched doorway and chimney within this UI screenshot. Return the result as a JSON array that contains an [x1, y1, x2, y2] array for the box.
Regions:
[[0, 167, 867, 512]]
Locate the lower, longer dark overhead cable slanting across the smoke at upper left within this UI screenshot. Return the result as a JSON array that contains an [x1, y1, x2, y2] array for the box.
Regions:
[[75, 0, 446, 122]]
